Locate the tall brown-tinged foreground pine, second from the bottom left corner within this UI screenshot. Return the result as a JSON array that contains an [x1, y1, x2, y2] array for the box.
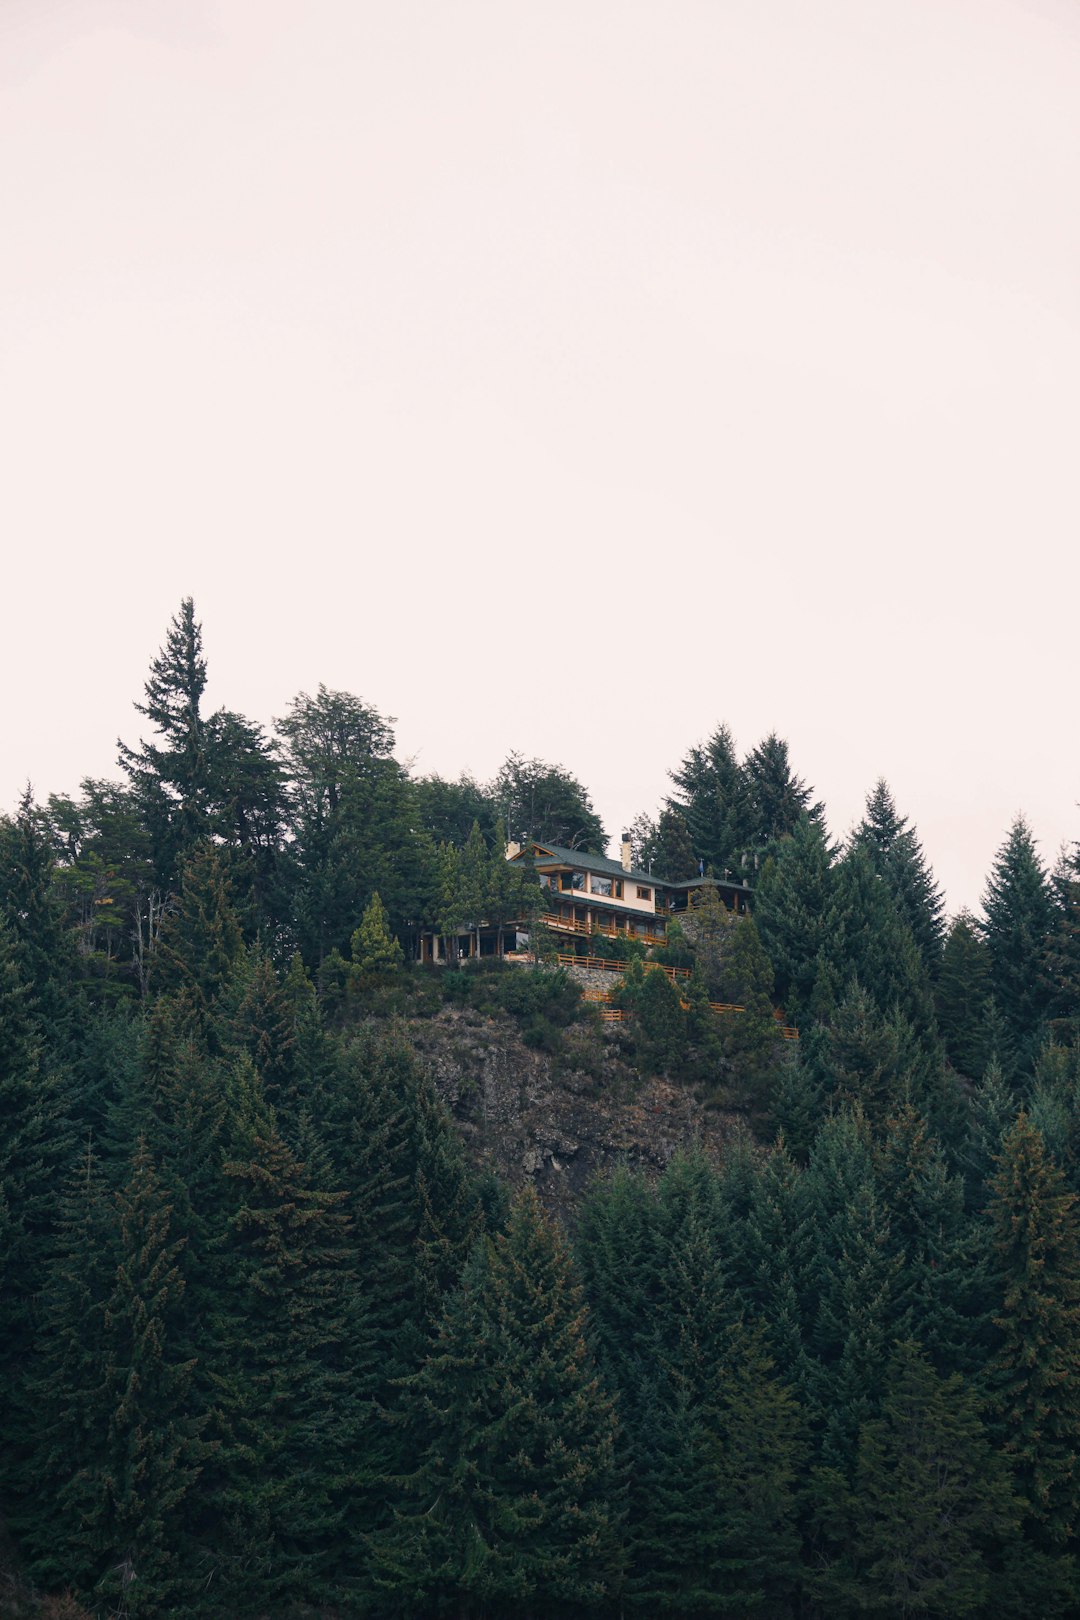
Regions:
[[196, 1095, 363, 1617]]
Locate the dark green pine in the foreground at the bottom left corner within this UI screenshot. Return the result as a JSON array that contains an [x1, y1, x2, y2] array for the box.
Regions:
[[18, 1144, 206, 1617]]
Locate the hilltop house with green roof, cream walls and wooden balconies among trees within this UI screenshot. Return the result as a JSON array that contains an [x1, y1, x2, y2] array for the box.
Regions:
[[419, 833, 750, 962]]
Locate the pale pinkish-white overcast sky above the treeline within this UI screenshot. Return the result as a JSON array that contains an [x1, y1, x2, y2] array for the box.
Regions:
[[0, 0, 1080, 907]]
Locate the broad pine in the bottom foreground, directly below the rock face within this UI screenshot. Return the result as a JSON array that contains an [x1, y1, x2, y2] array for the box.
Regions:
[[374, 1189, 622, 1620]]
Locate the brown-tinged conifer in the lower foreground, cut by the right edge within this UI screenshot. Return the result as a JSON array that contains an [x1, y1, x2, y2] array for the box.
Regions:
[[986, 1115, 1080, 1552]]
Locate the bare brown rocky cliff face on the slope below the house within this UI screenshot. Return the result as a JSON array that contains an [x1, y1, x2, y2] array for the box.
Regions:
[[410, 1009, 732, 1220]]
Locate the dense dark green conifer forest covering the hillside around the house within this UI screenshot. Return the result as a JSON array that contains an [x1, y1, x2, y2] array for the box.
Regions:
[[0, 599, 1080, 1620]]
